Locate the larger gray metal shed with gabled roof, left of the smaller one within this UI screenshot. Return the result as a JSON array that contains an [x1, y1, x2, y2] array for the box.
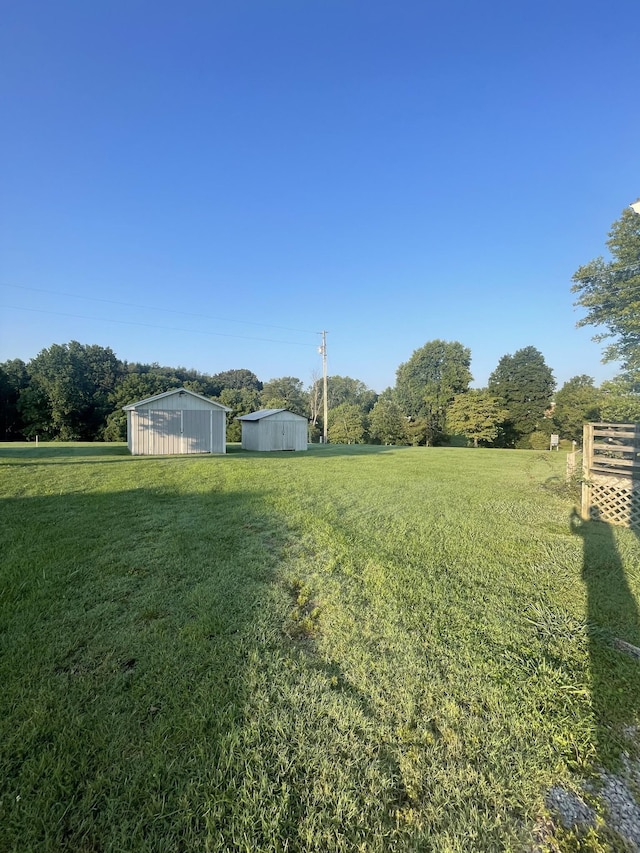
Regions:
[[122, 388, 231, 456]]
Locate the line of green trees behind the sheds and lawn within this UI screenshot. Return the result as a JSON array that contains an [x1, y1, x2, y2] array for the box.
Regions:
[[0, 201, 640, 448]]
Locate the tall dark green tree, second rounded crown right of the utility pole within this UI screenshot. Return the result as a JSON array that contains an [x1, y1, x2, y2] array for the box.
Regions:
[[488, 347, 556, 446]]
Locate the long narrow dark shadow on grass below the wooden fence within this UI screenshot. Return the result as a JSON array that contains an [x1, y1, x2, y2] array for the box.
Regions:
[[571, 510, 640, 765]]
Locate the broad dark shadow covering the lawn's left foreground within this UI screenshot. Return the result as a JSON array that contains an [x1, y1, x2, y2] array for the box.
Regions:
[[0, 482, 286, 851]]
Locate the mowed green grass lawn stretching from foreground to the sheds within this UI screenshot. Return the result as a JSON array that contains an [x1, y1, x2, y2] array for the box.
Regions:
[[0, 444, 640, 853]]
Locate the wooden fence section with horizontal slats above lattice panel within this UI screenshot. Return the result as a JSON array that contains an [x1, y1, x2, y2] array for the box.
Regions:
[[582, 424, 640, 528]]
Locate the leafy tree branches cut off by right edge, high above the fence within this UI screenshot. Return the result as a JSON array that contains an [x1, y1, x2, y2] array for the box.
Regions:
[[572, 203, 640, 374]]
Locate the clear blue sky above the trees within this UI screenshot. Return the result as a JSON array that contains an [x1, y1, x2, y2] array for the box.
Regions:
[[0, 0, 640, 391]]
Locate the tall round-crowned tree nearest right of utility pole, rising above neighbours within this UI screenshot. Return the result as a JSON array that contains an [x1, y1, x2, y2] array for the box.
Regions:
[[395, 340, 473, 444]]
